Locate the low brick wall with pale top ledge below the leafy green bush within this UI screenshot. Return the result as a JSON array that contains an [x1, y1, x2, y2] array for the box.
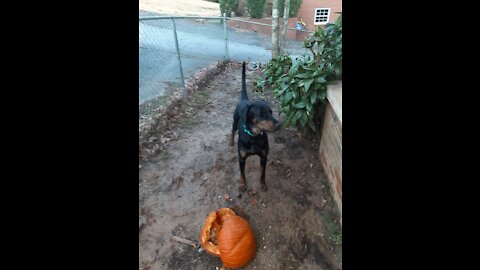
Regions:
[[319, 82, 342, 225]]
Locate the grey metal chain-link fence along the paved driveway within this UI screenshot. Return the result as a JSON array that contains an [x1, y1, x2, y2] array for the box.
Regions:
[[139, 16, 316, 125]]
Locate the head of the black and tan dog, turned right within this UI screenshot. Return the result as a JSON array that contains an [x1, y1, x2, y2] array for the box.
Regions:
[[246, 100, 281, 134]]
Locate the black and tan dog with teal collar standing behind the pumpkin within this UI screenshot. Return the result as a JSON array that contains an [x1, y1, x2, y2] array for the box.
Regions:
[[230, 62, 280, 191]]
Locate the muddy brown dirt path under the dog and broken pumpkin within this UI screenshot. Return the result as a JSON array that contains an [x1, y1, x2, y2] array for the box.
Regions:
[[139, 63, 341, 270]]
